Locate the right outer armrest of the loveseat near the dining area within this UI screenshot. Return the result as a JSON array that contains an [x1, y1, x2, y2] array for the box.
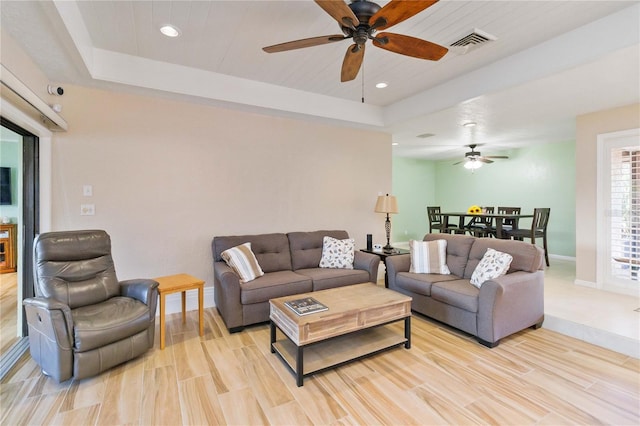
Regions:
[[478, 271, 544, 343]]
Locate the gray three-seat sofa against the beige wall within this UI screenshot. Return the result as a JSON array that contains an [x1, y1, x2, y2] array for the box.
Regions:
[[211, 230, 380, 332]]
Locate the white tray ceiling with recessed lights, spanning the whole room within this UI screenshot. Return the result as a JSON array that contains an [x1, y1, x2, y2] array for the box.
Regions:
[[0, 0, 640, 159]]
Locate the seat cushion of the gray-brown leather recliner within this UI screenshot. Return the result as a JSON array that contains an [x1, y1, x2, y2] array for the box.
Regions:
[[71, 296, 151, 352]]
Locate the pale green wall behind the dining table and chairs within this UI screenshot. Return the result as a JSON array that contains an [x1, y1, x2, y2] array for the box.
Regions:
[[392, 141, 576, 257]]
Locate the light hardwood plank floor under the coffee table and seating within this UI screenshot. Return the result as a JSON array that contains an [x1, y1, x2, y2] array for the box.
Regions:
[[0, 302, 640, 425]]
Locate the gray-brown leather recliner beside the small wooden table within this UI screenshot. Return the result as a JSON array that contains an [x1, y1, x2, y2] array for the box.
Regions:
[[23, 230, 158, 382]]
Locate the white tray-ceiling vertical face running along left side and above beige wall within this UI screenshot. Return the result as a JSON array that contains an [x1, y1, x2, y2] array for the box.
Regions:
[[55, 0, 384, 127]]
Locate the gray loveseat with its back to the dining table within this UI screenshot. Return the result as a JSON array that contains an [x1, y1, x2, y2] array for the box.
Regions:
[[386, 234, 544, 347]]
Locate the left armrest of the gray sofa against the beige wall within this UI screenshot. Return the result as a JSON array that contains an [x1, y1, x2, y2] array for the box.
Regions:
[[213, 262, 244, 330]]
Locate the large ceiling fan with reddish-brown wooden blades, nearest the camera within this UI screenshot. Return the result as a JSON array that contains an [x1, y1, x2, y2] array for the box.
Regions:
[[262, 0, 448, 82]]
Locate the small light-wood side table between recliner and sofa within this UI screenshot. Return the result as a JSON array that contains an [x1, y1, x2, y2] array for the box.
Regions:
[[154, 274, 204, 349]]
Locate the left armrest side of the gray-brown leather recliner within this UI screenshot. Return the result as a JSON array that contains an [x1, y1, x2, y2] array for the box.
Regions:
[[22, 297, 73, 382]]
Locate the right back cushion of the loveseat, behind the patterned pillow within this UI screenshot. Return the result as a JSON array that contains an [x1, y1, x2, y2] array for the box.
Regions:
[[464, 238, 544, 278]]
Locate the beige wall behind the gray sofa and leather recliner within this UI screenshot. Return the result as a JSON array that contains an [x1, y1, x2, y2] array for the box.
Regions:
[[51, 86, 391, 286]]
